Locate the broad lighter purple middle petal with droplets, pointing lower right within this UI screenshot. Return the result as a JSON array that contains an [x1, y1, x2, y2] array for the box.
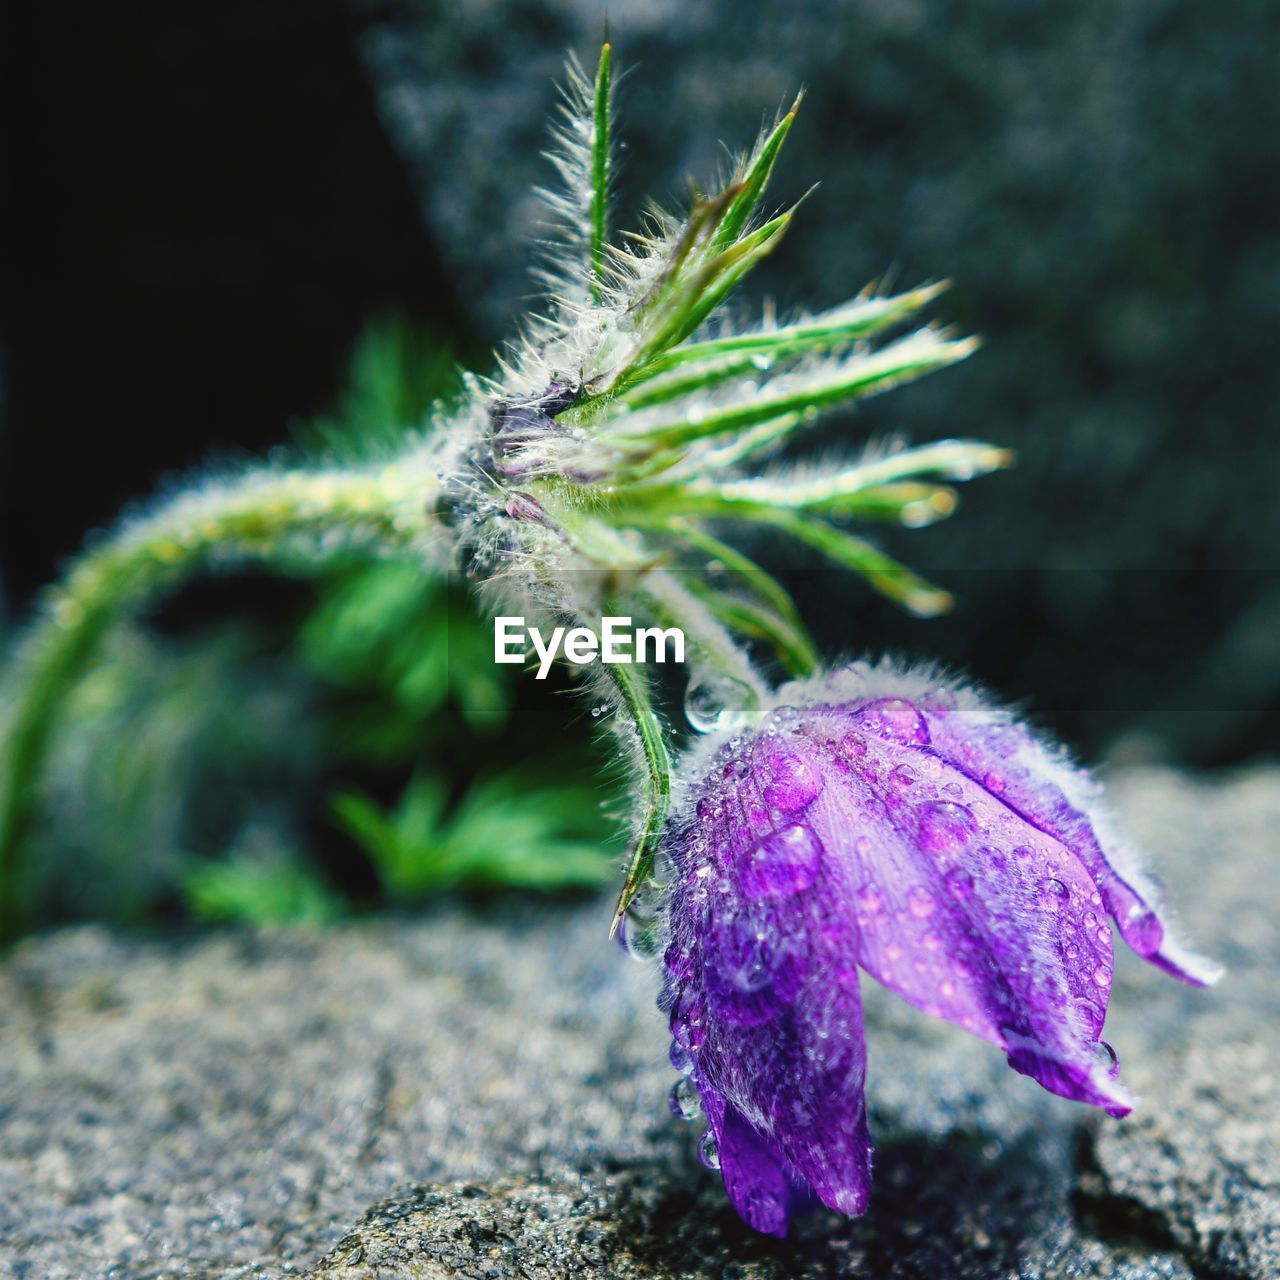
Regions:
[[805, 708, 1130, 1114]]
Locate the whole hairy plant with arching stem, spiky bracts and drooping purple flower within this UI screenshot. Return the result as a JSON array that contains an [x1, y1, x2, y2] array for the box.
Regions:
[[0, 45, 1206, 1231]]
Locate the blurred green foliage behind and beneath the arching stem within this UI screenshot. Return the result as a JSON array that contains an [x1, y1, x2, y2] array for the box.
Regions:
[[10, 319, 620, 942]]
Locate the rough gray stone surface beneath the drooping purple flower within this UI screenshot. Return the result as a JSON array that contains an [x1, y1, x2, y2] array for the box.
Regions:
[[0, 768, 1280, 1280]]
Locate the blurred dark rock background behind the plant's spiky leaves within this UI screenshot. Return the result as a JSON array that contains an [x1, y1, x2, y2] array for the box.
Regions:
[[0, 0, 1280, 783]]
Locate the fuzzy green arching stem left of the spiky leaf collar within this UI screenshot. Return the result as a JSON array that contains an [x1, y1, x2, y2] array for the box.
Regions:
[[0, 468, 431, 941]]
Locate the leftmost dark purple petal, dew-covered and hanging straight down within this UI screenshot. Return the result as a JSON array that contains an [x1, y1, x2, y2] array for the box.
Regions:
[[667, 757, 870, 1235]]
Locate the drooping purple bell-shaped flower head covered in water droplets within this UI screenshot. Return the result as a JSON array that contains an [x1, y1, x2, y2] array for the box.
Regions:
[[662, 664, 1216, 1235]]
